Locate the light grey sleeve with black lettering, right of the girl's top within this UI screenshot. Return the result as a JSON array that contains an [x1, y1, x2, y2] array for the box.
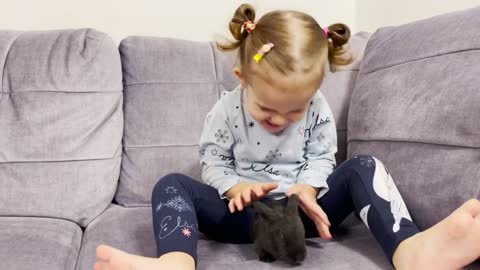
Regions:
[[297, 95, 337, 198]]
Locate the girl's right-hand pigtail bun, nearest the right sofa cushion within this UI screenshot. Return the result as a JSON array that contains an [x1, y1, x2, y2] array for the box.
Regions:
[[327, 23, 353, 66]]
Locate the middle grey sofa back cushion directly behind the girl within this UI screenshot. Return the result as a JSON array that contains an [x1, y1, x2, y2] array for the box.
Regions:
[[115, 33, 369, 206]]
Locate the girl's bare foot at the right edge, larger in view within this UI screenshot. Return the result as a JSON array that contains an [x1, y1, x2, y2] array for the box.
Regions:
[[393, 199, 480, 270]]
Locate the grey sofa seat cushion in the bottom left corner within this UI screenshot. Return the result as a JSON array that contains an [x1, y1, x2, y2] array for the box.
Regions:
[[0, 217, 82, 270]]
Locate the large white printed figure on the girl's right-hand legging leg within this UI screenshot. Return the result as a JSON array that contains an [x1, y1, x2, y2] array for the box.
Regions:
[[373, 158, 412, 232]]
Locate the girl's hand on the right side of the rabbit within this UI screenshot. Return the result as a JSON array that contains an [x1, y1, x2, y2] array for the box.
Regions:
[[285, 184, 332, 240]]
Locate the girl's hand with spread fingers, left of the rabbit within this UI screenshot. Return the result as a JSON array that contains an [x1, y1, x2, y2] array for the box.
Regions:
[[225, 182, 278, 213]]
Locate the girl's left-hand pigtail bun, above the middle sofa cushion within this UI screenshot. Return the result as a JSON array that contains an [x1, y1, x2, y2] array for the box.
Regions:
[[217, 4, 255, 51]]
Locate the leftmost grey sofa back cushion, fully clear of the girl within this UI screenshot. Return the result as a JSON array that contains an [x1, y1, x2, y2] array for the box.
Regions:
[[0, 29, 123, 226]]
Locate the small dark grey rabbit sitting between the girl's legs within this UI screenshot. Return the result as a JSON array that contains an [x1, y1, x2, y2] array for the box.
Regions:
[[253, 194, 306, 265]]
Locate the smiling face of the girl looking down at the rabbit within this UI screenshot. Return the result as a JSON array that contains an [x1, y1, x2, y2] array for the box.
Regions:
[[241, 68, 323, 133]]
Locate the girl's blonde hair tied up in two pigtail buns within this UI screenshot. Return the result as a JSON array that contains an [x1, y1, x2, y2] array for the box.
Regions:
[[217, 4, 353, 75]]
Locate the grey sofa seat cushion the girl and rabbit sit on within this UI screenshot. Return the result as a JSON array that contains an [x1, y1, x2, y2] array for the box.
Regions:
[[77, 205, 392, 270]]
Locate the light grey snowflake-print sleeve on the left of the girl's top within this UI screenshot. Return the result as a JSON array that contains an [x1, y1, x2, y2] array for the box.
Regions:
[[199, 100, 240, 198]]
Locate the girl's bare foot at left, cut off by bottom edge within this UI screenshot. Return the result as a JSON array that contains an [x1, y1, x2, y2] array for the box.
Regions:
[[94, 245, 195, 270]]
